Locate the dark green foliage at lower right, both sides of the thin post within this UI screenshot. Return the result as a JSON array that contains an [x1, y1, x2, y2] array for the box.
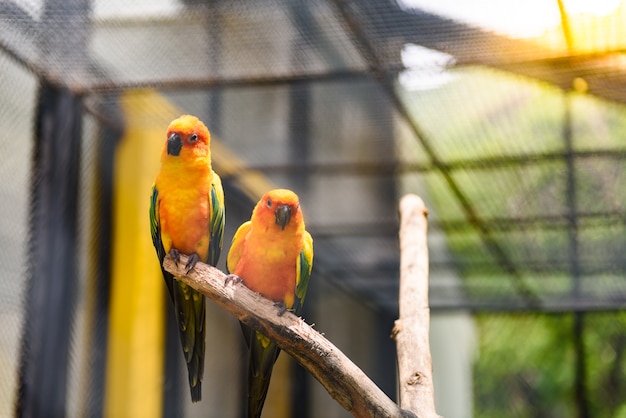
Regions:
[[474, 312, 626, 418]]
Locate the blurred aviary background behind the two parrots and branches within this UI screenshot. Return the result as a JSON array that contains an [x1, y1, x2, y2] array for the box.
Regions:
[[0, 0, 626, 418]]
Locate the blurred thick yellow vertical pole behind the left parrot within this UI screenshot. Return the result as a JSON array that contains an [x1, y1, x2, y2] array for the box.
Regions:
[[104, 90, 176, 418]]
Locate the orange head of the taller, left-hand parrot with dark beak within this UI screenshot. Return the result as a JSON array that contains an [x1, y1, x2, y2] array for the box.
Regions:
[[161, 115, 211, 164]]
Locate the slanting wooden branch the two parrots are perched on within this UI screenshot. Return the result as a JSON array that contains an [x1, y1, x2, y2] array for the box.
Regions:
[[163, 255, 416, 417]]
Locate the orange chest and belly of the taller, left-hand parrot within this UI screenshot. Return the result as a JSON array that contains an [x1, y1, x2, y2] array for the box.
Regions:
[[157, 185, 211, 260]]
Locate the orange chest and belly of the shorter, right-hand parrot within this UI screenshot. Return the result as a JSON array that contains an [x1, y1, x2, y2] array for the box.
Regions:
[[233, 232, 302, 308]]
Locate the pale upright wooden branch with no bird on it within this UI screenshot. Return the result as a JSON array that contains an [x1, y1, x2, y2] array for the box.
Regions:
[[392, 195, 438, 418]]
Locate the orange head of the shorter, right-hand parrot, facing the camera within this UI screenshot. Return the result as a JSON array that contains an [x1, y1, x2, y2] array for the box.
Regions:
[[252, 189, 304, 231]]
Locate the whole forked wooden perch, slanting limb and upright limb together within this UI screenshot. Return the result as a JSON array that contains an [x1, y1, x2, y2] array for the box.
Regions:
[[163, 195, 437, 418]]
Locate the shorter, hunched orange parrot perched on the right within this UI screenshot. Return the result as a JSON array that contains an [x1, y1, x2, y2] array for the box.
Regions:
[[226, 189, 313, 417]]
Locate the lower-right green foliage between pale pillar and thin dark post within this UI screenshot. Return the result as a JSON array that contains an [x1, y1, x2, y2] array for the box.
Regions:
[[474, 316, 575, 418]]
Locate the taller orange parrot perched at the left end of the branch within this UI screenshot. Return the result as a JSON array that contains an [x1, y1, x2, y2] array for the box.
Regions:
[[150, 115, 224, 402]]
